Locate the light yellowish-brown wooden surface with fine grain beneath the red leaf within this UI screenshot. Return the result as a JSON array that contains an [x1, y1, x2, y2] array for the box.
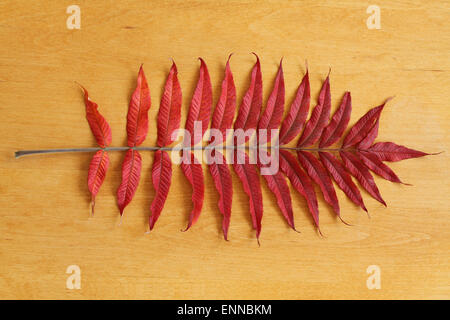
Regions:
[[0, 0, 450, 299]]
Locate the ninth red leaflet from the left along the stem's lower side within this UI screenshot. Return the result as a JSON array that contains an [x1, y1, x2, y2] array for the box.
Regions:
[[297, 151, 340, 217]]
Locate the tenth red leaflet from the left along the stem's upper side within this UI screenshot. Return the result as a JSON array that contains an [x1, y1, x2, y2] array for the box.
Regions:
[[319, 91, 352, 148]]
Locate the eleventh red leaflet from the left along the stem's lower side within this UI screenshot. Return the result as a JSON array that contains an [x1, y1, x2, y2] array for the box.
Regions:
[[339, 151, 386, 206]]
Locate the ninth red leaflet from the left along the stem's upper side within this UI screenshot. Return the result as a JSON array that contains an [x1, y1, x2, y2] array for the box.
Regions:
[[297, 74, 331, 148]]
